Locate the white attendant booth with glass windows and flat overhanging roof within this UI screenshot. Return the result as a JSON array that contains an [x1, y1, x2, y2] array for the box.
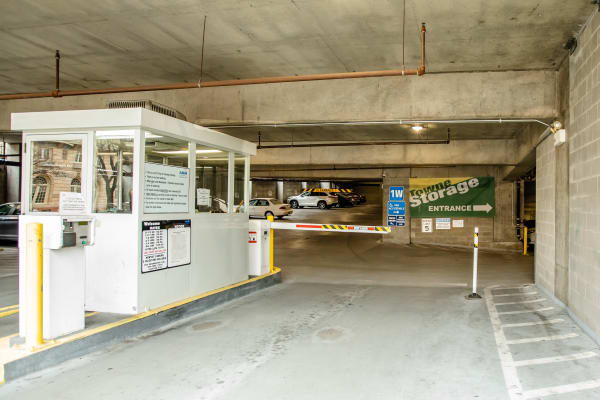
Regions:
[[11, 108, 256, 338]]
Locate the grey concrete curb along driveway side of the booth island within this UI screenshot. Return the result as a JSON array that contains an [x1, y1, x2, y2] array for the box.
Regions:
[[4, 271, 281, 382]]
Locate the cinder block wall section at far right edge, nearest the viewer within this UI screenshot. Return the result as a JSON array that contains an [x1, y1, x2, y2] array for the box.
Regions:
[[568, 13, 600, 335]]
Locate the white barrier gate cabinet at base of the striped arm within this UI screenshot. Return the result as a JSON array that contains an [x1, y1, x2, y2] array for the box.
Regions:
[[248, 220, 271, 276]]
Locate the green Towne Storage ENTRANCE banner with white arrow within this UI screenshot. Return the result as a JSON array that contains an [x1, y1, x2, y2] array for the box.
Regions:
[[410, 176, 496, 218]]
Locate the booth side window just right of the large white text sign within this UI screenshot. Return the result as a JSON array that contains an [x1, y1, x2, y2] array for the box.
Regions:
[[196, 145, 229, 213]]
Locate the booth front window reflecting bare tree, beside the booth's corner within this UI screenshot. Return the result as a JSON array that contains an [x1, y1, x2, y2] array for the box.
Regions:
[[94, 130, 135, 213]]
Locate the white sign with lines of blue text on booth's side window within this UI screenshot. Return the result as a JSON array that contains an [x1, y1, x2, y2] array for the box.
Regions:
[[144, 163, 190, 214]]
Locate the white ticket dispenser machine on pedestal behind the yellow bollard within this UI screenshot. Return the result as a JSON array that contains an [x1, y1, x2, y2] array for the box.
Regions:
[[21, 215, 95, 339]]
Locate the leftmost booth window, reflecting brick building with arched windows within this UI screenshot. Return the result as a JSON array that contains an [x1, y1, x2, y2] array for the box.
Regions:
[[30, 139, 83, 212]]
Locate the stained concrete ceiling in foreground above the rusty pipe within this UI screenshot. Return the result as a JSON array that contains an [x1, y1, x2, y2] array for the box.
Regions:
[[0, 0, 594, 93]]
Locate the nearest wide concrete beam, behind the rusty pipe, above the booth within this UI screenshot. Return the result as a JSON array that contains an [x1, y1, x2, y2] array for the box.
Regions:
[[0, 71, 557, 129]]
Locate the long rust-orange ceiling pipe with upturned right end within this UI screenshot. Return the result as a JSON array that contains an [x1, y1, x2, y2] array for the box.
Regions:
[[0, 23, 426, 100]]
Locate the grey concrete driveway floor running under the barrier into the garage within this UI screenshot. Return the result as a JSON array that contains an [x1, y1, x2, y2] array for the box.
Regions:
[[0, 206, 600, 400]]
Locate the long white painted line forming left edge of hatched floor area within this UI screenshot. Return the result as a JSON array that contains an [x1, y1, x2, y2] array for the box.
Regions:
[[484, 288, 523, 400]]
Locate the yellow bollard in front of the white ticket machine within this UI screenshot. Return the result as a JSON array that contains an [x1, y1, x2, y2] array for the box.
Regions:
[[25, 223, 44, 348]]
